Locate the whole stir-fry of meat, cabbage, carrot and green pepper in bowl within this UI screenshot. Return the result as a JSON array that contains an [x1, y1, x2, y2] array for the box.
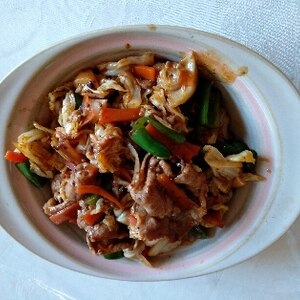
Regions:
[[5, 52, 262, 265]]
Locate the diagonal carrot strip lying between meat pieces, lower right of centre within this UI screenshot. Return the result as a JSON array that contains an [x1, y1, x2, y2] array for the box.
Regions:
[[157, 173, 195, 210]]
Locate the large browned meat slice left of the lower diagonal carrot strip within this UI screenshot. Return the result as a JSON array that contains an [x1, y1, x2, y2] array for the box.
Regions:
[[128, 156, 180, 218]]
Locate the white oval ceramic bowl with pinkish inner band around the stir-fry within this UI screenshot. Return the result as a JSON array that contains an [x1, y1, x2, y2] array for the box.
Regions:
[[0, 26, 300, 280]]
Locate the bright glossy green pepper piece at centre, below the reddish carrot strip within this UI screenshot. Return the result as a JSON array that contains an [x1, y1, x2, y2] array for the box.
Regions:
[[130, 127, 171, 158]]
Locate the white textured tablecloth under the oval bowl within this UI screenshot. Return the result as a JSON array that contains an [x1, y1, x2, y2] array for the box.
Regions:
[[0, 0, 300, 300]]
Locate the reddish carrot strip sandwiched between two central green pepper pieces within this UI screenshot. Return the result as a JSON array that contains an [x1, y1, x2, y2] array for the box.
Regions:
[[145, 123, 201, 161]]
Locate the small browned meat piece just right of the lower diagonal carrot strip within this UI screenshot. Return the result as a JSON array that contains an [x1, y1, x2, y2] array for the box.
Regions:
[[174, 163, 206, 197]]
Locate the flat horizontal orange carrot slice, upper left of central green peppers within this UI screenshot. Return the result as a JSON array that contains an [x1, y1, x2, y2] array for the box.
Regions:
[[99, 107, 140, 124]]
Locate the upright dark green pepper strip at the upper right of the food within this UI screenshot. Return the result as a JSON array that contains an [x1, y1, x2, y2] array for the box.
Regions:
[[199, 81, 221, 128]]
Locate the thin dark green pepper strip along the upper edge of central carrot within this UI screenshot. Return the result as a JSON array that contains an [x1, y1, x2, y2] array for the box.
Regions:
[[133, 117, 185, 144]]
